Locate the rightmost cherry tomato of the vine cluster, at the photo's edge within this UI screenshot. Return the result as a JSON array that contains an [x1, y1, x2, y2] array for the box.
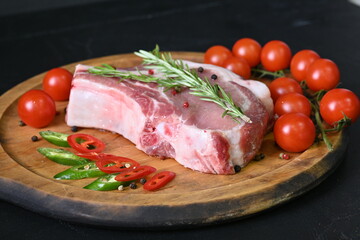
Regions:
[[320, 88, 360, 125]]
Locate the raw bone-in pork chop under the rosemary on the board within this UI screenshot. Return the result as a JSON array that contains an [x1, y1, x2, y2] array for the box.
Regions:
[[66, 61, 273, 174]]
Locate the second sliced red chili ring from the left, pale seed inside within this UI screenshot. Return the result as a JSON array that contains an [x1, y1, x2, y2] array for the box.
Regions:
[[95, 155, 140, 173]]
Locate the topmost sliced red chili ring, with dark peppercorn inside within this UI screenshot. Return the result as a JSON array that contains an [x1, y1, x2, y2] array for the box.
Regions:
[[67, 133, 105, 153]]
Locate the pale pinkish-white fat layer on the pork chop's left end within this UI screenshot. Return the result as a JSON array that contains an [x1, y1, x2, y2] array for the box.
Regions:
[[67, 78, 145, 145]]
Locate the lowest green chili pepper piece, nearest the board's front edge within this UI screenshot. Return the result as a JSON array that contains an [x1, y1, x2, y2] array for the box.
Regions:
[[84, 174, 132, 191]]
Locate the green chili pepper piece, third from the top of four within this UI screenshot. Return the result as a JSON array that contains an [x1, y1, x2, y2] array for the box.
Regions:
[[54, 162, 107, 180]]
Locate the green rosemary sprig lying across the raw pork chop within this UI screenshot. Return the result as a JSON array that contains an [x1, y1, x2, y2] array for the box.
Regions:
[[88, 46, 251, 123]]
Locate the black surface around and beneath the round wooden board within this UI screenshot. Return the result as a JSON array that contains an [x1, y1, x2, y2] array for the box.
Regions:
[[0, 0, 360, 240]]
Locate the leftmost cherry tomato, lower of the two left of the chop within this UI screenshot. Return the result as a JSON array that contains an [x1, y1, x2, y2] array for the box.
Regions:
[[17, 90, 56, 128]]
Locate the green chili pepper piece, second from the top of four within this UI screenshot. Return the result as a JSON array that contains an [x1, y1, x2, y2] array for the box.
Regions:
[[37, 148, 89, 166]]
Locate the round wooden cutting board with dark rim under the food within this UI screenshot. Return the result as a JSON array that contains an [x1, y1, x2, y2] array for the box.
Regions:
[[0, 52, 348, 228]]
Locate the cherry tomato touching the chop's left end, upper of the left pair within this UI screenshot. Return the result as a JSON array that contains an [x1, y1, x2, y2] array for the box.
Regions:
[[42, 68, 73, 101]]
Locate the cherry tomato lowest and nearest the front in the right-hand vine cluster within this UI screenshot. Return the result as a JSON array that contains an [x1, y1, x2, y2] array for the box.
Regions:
[[274, 113, 315, 152]]
